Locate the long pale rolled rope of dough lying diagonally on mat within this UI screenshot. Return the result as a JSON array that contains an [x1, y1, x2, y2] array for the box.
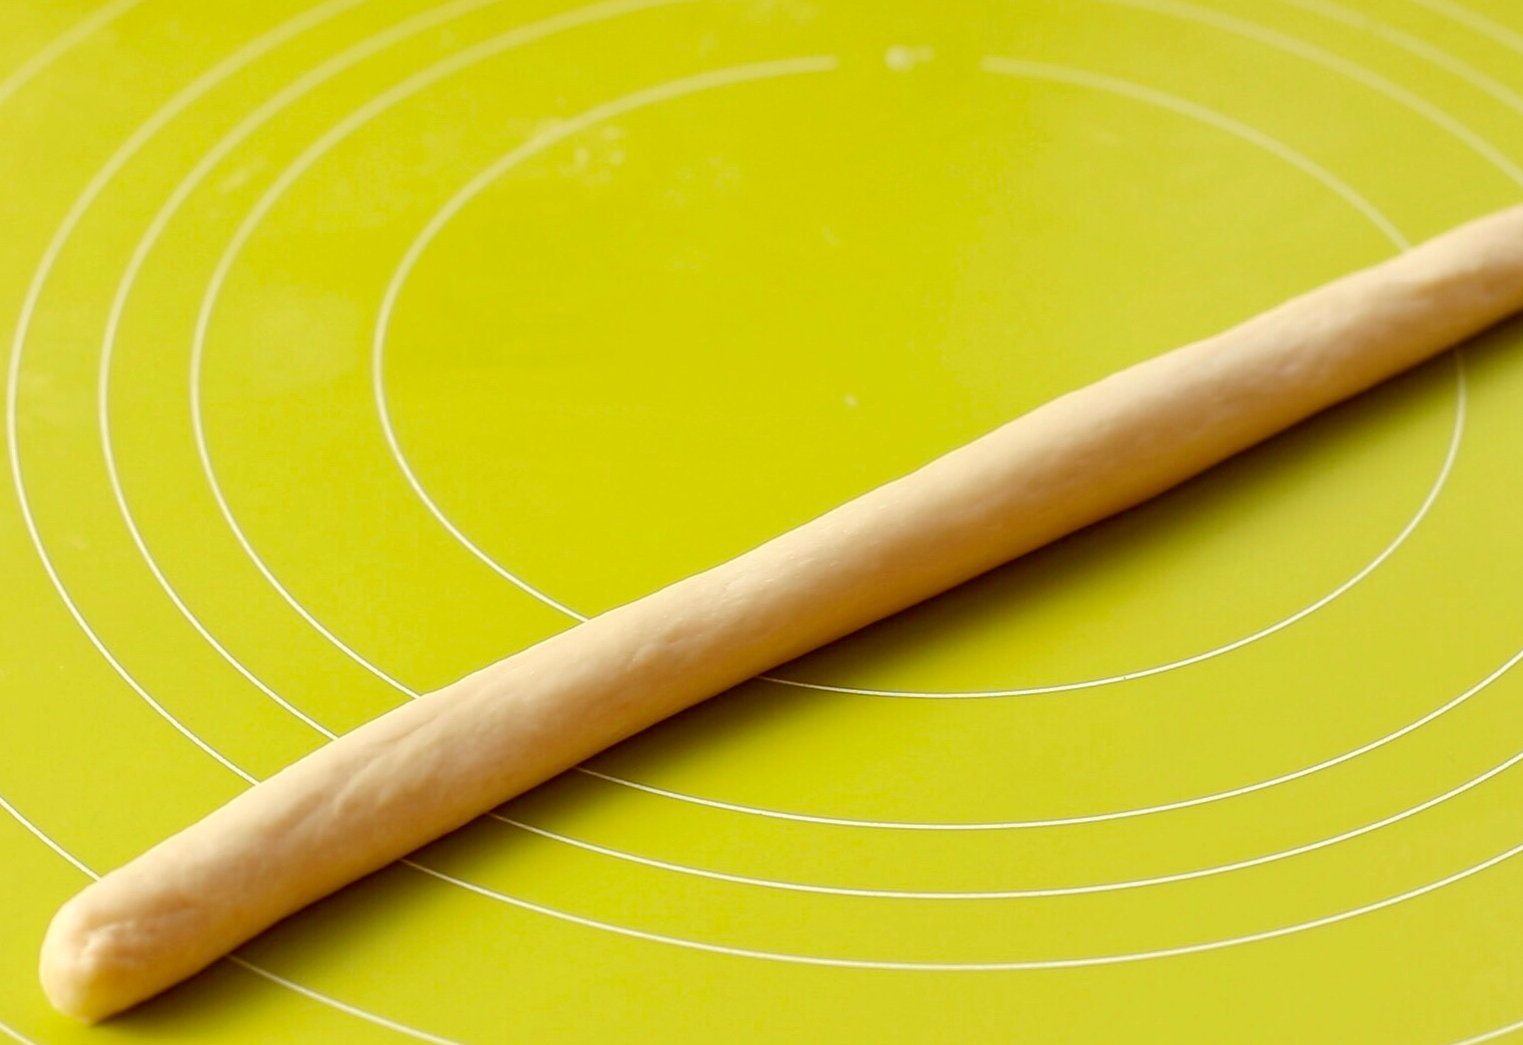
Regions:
[[41, 207, 1523, 1021]]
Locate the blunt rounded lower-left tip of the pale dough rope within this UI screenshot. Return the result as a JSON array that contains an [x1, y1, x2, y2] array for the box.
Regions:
[[38, 888, 162, 1024]]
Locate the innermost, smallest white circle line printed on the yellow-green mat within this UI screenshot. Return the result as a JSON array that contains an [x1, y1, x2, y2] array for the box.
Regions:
[[372, 49, 1465, 699]]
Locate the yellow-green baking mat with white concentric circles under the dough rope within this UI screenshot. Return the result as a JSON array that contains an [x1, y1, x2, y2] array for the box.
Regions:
[[0, 0, 1523, 1045]]
